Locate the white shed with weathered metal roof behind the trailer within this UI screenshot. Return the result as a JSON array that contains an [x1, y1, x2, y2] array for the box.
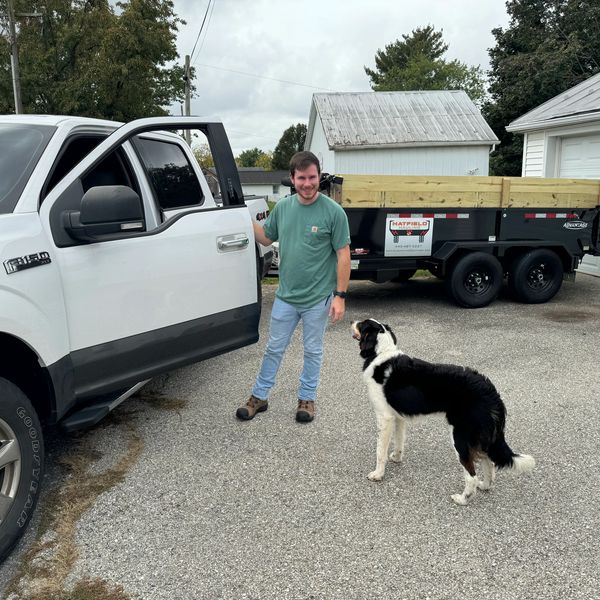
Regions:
[[304, 91, 499, 175]]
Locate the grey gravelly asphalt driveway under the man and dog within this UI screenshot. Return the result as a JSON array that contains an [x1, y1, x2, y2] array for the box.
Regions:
[[0, 275, 600, 600]]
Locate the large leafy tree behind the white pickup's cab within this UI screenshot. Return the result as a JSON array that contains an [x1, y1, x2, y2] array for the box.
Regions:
[[0, 0, 184, 121]]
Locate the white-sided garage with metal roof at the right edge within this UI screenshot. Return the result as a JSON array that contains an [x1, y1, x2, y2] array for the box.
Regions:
[[506, 73, 600, 275]]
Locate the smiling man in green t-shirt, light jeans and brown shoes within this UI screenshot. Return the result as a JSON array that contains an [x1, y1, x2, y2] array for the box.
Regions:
[[236, 152, 350, 422]]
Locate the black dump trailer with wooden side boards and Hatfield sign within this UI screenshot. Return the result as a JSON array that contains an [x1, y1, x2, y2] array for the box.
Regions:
[[321, 174, 600, 308]]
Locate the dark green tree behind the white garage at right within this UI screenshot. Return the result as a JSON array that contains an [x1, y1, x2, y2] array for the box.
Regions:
[[483, 0, 600, 175]]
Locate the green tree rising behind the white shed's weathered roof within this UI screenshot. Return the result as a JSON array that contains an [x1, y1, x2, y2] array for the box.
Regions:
[[365, 25, 485, 103]]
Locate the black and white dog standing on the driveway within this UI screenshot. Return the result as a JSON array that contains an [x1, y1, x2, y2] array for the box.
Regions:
[[352, 319, 535, 505]]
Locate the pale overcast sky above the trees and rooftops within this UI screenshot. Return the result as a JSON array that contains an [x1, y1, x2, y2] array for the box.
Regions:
[[172, 0, 508, 155]]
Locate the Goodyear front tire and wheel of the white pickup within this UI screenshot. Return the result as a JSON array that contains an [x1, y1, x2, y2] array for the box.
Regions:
[[0, 377, 44, 560]]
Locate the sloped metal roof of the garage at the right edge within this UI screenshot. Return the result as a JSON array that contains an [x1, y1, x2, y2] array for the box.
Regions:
[[506, 73, 600, 132]]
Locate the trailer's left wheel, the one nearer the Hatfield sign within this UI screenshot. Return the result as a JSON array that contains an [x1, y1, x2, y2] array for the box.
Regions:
[[446, 252, 503, 308]]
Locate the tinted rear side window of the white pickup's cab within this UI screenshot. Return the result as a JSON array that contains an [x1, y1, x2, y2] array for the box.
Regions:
[[135, 138, 204, 210]]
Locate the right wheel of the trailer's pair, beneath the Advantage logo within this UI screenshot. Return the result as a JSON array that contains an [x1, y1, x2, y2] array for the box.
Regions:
[[508, 248, 563, 304]]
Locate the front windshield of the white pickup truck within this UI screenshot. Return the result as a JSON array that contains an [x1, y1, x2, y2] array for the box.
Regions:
[[0, 123, 56, 214]]
